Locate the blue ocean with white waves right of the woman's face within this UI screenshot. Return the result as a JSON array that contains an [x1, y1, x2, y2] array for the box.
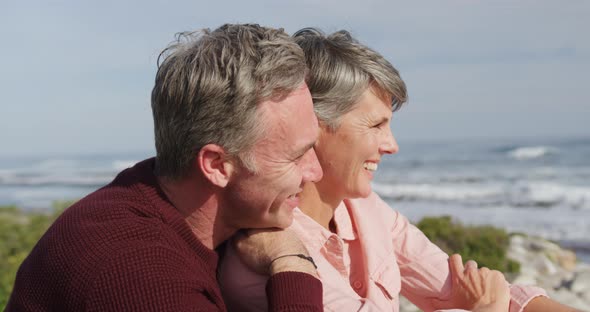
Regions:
[[373, 138, 590, 263]]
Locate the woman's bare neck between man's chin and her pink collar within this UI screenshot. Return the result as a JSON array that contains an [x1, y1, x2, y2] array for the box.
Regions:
[[299, 182, 343, 232]]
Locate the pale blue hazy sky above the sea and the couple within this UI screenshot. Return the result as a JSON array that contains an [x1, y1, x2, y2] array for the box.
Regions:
[[0, 0, 590, 156]]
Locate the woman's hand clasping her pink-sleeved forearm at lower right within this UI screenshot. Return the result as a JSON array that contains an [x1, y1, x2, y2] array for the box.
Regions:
[[430, 254, 510, 312]]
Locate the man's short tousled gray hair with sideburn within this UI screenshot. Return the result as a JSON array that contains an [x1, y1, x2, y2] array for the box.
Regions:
[[152, 24, 307, 178]]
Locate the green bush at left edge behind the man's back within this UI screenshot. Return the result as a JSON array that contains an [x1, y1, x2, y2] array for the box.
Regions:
[[0, 201, 72, 311]]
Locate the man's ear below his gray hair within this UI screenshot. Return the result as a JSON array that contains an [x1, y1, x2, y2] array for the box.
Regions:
[[197, 144, 234, 187]]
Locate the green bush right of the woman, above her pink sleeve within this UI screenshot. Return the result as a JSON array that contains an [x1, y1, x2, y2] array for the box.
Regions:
[[417, 216, 520, 273]]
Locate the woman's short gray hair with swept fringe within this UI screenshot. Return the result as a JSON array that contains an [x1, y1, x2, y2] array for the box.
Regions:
[[293, 28, 407, 131]]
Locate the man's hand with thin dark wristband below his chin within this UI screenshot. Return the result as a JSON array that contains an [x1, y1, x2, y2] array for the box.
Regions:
[[233, 229, 318, 278]]
